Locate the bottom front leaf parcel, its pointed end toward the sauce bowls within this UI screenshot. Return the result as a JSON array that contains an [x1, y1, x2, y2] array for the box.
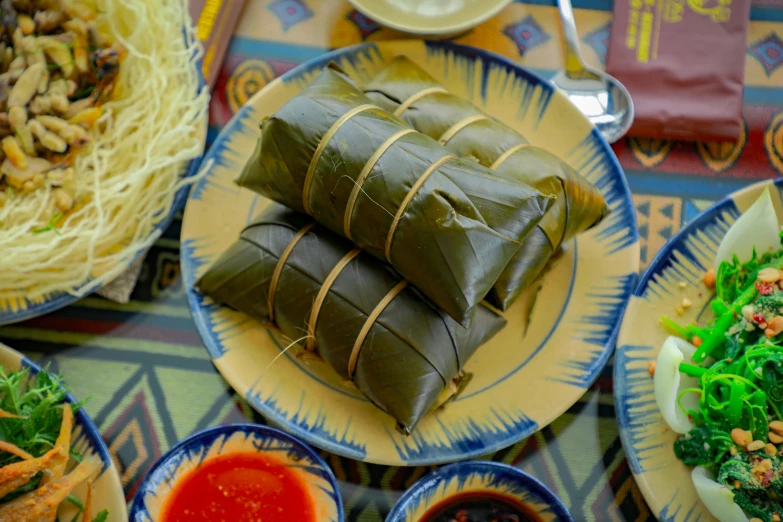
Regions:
[[196, 205, 505, 433]]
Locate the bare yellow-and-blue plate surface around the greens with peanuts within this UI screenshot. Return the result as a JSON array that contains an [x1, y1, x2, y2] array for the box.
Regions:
[[614, 179, 783, 522]]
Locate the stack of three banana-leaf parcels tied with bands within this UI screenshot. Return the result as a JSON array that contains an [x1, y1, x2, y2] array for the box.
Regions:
[[197, 60, 606, 433]]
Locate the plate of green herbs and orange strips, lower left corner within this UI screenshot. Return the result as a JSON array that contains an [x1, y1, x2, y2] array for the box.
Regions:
[[0, 344, 128, 522]]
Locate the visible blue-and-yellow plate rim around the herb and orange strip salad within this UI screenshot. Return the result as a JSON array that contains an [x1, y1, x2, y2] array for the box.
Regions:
[[0, 344, 128, 522]]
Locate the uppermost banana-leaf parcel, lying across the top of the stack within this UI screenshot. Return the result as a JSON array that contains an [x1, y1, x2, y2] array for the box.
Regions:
[[237, 66, 554, 326]]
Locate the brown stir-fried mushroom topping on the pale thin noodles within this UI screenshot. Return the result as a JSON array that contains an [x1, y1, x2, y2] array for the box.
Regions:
[[0, 0, 123, 216]]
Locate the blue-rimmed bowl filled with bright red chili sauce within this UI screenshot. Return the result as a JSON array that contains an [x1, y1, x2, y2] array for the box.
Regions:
[[130, 424, 343, 522]]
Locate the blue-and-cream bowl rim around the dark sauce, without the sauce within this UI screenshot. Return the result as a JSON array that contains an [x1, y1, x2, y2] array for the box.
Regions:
[[386, 461, 574, 522]]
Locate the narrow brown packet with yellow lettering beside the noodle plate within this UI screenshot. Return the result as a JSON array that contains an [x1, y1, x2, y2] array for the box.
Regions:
[[190, 0, 247, 89]]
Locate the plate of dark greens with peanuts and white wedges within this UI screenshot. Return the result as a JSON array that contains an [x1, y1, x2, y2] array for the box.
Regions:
[[615, 179, 783, 522]]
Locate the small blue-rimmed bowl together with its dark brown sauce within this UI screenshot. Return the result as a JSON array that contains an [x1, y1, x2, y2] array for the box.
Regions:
[[386, 461, 574, 522]]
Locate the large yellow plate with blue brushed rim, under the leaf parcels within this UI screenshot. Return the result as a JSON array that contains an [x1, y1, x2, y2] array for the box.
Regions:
[[181, 41, 639, 466]]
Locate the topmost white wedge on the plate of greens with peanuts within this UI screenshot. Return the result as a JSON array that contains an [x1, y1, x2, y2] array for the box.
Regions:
[[715, 188, 780, 271]]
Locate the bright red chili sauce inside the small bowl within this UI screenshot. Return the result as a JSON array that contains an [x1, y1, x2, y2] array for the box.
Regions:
[[160, 453, 317, 522]]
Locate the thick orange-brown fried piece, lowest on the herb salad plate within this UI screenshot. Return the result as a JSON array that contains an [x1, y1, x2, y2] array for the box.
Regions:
[[0, 448, 101, 522]]
